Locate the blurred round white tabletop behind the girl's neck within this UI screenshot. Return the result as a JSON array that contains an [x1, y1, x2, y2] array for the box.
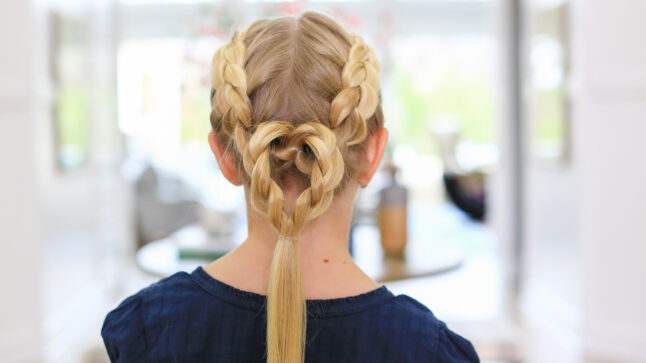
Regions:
[[136, 220, 465, 282]]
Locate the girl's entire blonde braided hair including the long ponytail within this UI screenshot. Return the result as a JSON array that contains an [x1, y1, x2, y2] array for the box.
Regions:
[[211, 12, 383, 363]]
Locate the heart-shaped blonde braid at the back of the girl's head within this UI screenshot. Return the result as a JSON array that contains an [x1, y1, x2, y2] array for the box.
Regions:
[[242, 121, 343, 236]]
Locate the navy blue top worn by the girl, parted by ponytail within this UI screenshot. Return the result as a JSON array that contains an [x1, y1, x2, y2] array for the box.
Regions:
[[101, 267, 479, 363]]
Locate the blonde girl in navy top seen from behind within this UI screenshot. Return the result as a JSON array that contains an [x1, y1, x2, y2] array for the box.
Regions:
[[102, 12, 478, 363]]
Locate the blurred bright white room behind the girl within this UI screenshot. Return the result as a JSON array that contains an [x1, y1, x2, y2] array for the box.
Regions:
[[0, 0, 646, 362]]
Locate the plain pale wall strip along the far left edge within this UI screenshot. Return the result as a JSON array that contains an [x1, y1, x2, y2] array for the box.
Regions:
[[0, 1, 42, 362]]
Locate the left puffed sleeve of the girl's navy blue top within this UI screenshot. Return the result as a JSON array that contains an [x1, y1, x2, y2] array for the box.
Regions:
[[101, 294, 146, 362]]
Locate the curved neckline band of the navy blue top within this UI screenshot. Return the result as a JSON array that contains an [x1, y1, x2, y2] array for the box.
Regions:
[[190, 266, 395, 318]]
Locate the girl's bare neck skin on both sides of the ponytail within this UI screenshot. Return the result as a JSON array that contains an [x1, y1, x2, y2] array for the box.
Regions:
[[204, 186, 379, 299]]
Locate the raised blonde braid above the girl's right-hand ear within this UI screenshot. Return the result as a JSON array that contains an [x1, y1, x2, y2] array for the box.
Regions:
[[330, 36, 380, 146]]
